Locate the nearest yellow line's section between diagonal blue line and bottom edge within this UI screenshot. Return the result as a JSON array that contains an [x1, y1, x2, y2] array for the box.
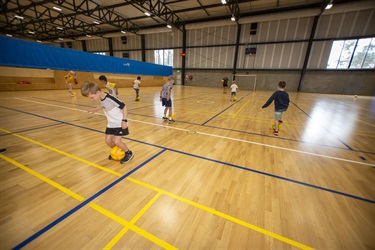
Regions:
[[90, 203, 178, 249]]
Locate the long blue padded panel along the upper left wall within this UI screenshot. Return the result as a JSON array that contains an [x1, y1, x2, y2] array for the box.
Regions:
[[0, 36, 173, 76]]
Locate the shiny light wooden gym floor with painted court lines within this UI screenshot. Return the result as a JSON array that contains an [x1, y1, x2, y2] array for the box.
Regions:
[[0, 86, 375, 249]]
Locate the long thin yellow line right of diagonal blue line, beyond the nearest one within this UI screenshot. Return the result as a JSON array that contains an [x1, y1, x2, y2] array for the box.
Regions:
[[126, 177, 314, 250]]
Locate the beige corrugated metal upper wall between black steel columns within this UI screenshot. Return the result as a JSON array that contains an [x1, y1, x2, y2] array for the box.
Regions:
[[73, 9, 375, 70]]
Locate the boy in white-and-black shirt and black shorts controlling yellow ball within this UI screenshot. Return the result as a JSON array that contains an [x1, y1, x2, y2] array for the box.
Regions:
[[81, 82, 134, 164]]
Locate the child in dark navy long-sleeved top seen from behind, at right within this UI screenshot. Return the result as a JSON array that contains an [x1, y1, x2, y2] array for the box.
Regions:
[[262, 81, 290, 135]]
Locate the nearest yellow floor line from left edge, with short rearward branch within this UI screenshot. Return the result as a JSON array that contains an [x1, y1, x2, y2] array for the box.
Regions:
[[0, 155, 177, 249]]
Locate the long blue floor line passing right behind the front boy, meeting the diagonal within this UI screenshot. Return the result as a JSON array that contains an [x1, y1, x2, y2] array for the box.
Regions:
[[0, 106, 375, 203]]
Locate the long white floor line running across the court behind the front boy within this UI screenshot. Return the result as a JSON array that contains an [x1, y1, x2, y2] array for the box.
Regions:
[[14, 97, 374, 167]]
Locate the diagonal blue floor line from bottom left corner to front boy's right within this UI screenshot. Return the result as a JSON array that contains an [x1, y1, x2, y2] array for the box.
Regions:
[[12, 149, 166, 249]]
